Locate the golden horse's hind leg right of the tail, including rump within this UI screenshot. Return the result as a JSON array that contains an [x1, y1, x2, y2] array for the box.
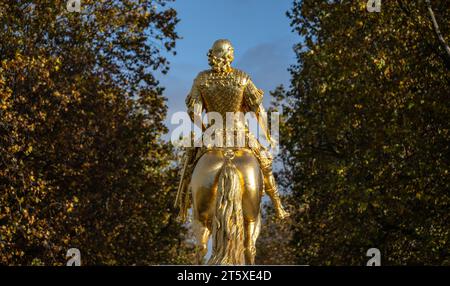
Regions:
[[235, 151, 263, 264]]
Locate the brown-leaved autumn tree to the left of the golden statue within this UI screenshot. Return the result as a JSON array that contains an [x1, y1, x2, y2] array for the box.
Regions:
[[0, 0, 189, 265]]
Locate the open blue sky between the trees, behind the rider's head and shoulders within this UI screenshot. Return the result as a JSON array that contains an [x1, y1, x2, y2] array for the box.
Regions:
[[159, 0, 298, 129]]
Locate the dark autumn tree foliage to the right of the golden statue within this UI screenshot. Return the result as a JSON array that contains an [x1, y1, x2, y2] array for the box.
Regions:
[[281, 0, 450, 265]]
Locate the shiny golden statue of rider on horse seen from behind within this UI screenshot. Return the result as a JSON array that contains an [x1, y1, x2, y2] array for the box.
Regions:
[[175, 40, 288, 265]]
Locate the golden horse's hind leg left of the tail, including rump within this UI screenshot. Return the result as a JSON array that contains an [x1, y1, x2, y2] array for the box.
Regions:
[[190, 151, 223, 264]]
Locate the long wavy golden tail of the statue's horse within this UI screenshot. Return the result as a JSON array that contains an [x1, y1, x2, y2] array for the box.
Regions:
[[208, 150, 245, 265]]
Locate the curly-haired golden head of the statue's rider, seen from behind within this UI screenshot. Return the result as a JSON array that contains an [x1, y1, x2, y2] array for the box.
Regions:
[[208, 39, 234, 72]]
